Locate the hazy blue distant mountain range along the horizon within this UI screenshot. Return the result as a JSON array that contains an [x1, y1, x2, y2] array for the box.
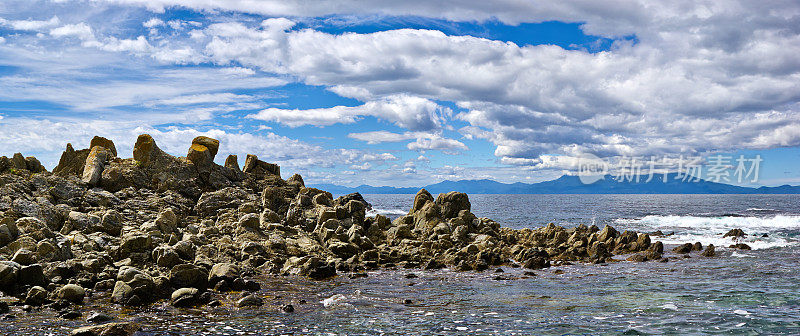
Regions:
[[309, 174, 800, 194]]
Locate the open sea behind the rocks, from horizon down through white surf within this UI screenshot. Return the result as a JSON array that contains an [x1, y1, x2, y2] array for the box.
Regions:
[[365, 194, 800, 249]]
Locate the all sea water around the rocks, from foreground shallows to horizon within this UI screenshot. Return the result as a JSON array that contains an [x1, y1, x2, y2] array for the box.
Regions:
[[6, 195, 800, 335]]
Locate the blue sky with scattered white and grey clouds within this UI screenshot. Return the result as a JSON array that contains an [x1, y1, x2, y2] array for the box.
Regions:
[[0, 0, 800, 186]]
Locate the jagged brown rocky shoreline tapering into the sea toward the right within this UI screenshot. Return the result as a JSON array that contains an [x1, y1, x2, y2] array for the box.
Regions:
[[0, 134, 720, 335]]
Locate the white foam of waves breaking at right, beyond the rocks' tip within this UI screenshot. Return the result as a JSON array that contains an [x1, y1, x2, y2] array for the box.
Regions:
[[615, 215, 800, 250]]
